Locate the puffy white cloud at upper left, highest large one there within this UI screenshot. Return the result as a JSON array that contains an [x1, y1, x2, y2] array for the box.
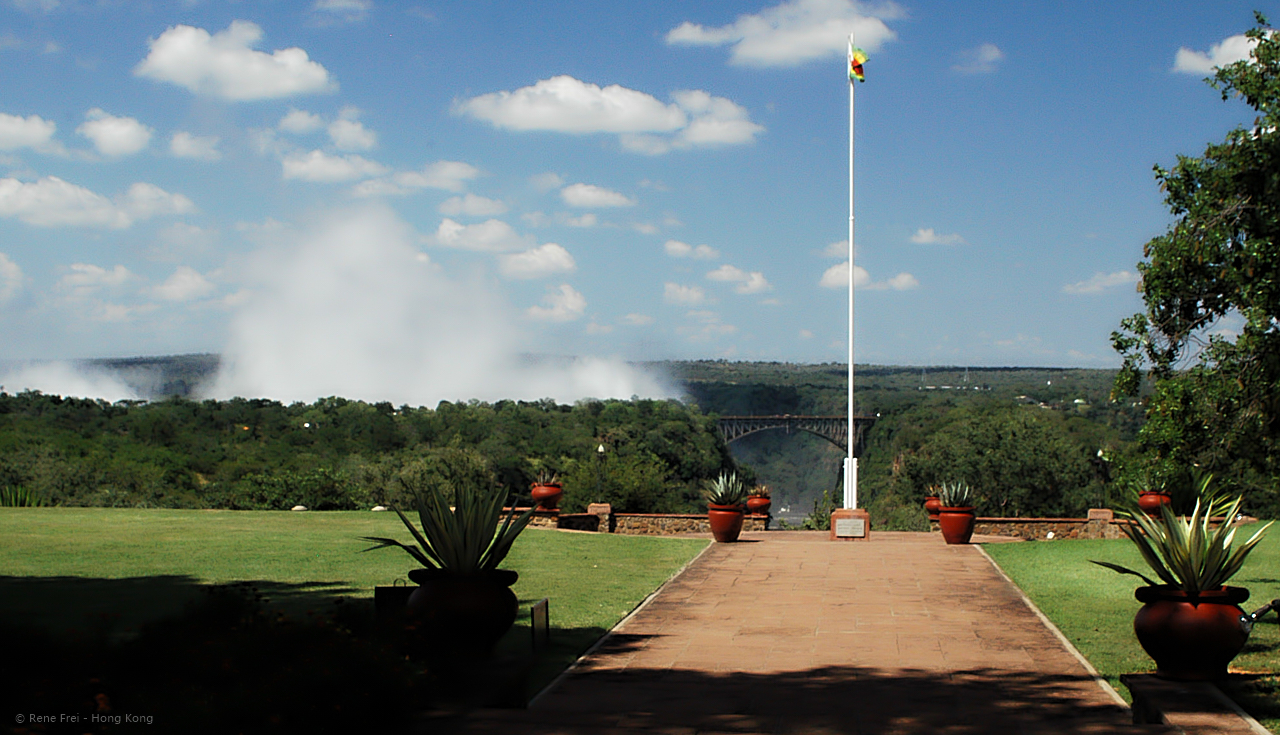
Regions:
[[133, 20, 338, 101]]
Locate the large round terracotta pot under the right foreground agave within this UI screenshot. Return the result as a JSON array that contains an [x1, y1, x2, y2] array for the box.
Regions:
[[1133, 585, 1249, 681]]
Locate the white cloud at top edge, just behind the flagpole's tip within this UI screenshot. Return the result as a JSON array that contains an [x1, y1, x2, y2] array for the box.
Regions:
[[667, 0, 904, 67]]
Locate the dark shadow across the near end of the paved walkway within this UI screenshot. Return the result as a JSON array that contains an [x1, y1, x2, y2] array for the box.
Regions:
[[452, 665, 1132, 735]]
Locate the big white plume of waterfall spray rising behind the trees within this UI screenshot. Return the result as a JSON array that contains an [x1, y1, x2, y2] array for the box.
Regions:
[[210, 205, 673, 406]]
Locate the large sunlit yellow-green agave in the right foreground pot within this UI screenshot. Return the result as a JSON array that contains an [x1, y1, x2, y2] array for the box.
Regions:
[[1093, 476, 1271, 594]]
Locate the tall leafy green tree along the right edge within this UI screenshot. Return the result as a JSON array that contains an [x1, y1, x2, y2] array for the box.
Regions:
[[1112, 14, 1280, 516]]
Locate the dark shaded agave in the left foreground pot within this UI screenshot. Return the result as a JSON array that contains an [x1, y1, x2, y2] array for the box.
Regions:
[[362, 484, 534, 575]]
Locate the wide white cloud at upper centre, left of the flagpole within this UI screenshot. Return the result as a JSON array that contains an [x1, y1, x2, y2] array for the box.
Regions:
[[454, 74, 764, 155]]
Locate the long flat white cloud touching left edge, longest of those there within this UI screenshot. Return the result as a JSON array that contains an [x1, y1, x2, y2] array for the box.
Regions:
[[0, 177, 196, 229]]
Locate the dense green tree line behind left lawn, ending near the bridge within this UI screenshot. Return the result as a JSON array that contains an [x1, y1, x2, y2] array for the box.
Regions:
[[0, 392, 736, 512]]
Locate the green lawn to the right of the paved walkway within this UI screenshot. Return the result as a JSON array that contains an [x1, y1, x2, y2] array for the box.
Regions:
[[984, 525, 1280, 732]]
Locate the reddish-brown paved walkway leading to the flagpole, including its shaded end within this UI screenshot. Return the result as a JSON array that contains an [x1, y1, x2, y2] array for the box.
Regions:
[[465, 533, 1165, 735]]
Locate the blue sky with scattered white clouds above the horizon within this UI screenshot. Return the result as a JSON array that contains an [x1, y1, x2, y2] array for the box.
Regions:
[[0, 0, 1280, 404]]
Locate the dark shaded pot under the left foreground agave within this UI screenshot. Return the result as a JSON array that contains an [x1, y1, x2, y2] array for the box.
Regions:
[[406, 569, 520, 656]]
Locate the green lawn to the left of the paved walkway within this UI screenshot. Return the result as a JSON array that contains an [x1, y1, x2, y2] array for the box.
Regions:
[[0, 507, 708, 706]]
